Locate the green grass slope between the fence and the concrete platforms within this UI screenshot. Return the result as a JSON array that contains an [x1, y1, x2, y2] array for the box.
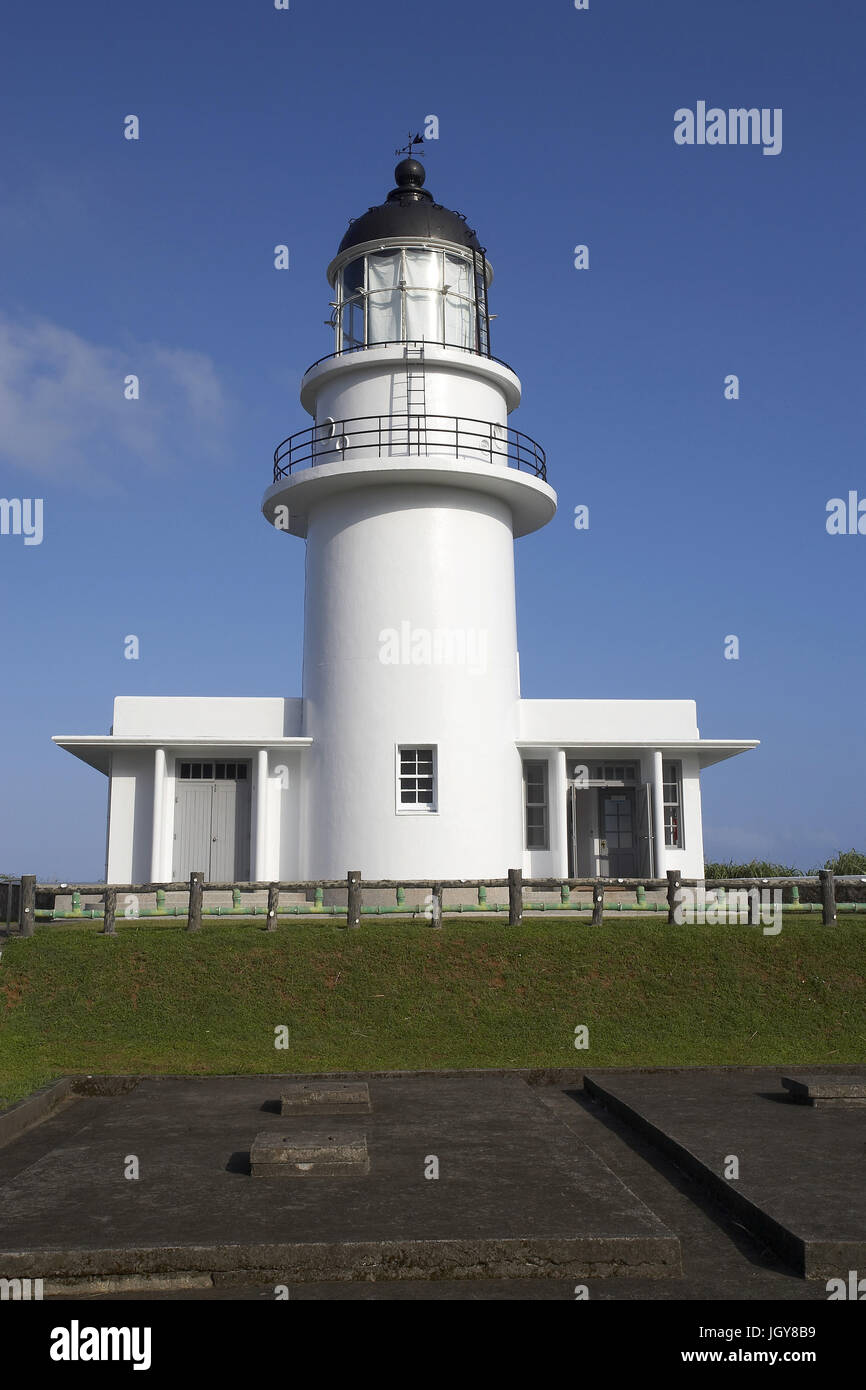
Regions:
[[0, 913, 866, 1105]]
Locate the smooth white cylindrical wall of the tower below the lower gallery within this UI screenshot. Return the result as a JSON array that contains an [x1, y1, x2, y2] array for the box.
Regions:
[[303, 485, 523, 878]]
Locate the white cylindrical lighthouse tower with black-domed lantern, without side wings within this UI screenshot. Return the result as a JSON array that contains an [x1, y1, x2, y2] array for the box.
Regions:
[[263, 158, 556, 878]]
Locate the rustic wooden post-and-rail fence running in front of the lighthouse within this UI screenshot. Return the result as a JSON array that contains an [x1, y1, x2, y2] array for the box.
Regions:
[[0, 869, 863, 937]]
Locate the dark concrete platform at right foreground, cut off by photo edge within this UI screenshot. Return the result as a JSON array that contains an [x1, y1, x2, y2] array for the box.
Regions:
[[584, 1066, 866, 1280]]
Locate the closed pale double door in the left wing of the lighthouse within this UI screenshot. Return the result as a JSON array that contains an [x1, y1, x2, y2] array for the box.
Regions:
[[172, 763, 250, 883]]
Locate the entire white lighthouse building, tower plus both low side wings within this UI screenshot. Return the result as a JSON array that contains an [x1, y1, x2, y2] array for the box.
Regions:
[[54, 158, 755, 883]]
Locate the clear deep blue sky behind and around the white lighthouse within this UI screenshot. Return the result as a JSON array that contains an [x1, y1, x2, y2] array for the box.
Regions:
[[0, 0, 866, 878]]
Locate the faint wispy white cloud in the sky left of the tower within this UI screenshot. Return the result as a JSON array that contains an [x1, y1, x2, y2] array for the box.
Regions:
[[0, 314, 225, 491]]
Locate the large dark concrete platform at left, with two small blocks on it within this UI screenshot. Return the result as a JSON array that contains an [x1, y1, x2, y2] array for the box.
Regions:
[[0, 1076, 681, 1294]]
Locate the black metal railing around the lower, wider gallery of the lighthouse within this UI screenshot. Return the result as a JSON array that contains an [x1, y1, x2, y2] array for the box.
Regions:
[[274, 413, 548, 482]]
